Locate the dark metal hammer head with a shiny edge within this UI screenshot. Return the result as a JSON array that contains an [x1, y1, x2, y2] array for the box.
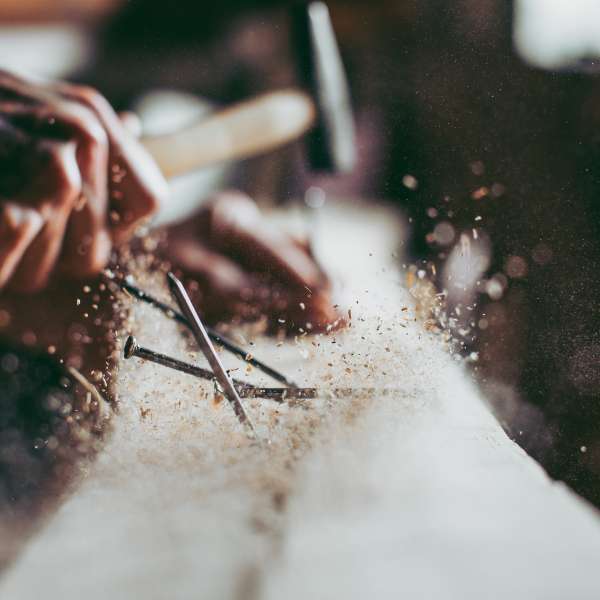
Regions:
[[292, 2, 356, 173]]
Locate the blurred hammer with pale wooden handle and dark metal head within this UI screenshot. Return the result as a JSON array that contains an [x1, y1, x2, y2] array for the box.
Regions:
[[142, 2, 355, 178]]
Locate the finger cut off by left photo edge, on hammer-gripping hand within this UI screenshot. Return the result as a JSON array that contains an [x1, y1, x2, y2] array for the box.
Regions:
[[0, 202, 44, 289]]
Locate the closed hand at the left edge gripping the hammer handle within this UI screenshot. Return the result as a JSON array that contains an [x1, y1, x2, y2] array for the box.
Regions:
[[0, 71, 167, 291]]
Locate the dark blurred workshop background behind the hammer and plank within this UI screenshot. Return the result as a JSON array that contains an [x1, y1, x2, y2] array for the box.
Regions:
[[0, 0, 600, 506]]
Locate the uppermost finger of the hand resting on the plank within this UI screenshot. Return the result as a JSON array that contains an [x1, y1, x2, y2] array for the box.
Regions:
[[204, 192, 327, 290]]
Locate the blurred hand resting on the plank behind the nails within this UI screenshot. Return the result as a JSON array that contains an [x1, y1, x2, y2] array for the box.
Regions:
[[168, 191, 342, 332]]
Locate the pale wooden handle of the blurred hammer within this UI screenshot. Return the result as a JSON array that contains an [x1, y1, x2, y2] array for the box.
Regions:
[[142, 90, 315, 177]]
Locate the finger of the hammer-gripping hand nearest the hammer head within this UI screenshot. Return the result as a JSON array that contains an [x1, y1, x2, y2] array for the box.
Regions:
[[54, 83, 168, 243]]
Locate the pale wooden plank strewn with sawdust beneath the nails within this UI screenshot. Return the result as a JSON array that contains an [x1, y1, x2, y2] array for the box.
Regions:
[[0, 202, 600, 600]]
